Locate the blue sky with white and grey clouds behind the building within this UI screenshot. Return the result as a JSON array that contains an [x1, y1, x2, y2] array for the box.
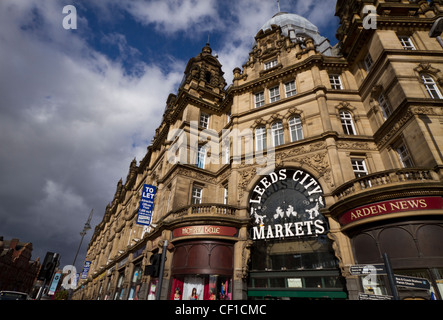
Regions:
[[0, 0, 338, 269]]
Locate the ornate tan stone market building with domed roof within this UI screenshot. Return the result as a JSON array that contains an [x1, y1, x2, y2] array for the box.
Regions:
[[74, 0, 443, 300]]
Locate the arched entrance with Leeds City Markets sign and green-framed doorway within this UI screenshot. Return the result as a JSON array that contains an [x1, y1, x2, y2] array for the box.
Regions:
[[248, 168, 347, 299]]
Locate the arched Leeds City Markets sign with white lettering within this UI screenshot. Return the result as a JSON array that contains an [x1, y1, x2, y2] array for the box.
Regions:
[[249, 168, 328, 240]]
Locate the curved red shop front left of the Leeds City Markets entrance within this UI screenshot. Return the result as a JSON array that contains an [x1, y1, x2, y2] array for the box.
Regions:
[[170, 226, 237, 300]]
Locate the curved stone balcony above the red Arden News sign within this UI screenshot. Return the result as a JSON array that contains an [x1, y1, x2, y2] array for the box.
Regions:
[[332, 168, 443, 202]]
